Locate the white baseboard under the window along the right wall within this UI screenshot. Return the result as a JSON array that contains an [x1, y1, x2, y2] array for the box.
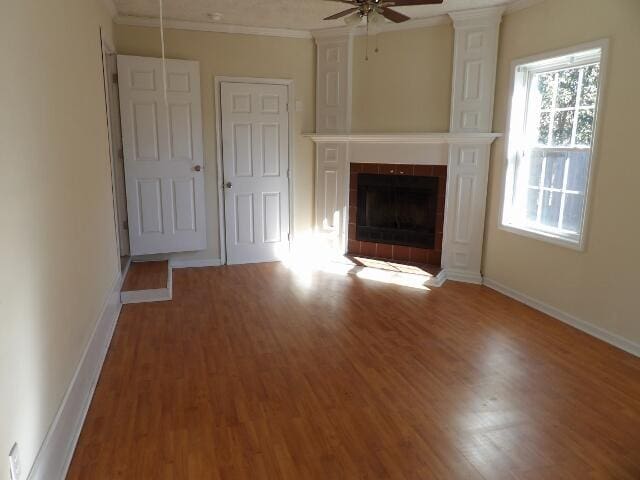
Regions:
[[483, 277, 640, 357]]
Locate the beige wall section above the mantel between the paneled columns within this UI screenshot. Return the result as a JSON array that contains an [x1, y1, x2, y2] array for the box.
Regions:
[[352, 23, 453, 132]]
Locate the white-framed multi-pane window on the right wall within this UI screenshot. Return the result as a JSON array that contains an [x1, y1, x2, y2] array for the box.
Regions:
[[502, 44, 604, 248]]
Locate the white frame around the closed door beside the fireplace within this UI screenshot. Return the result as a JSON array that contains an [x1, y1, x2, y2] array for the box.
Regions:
[[213, 76, 295, 265]]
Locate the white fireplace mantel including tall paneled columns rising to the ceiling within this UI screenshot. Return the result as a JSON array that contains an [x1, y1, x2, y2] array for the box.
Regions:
[[306, 7, 504, 283]]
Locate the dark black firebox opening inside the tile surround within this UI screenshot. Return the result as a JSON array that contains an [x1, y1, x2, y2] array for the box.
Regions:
[[356, 173, 438, 248]]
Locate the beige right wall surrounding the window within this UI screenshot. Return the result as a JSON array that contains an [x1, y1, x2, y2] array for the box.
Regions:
[[484, 0, 640, 344]]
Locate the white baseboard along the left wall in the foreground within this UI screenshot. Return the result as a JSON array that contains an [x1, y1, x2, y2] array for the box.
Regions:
[[27, 268, 124, 480]]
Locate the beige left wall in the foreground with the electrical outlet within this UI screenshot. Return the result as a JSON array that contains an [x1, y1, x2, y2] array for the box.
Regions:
[[0, 0, 118, 479]]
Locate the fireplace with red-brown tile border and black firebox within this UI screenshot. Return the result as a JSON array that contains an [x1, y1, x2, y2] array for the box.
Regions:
[[348, 163, 447, 266]]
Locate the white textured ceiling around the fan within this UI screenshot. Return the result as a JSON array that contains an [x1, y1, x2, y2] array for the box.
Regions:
[[114, 0, 523, 30]]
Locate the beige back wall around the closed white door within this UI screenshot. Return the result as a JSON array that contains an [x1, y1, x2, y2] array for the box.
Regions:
[[115, 25, 315, 259]]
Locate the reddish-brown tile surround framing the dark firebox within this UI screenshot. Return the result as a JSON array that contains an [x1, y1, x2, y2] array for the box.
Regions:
[[348, 163, 447, 267]]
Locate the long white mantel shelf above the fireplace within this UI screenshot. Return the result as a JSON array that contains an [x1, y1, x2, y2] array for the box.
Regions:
[[304, 133, 502, 144]]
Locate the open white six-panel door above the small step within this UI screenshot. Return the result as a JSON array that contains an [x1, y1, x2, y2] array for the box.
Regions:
[[118, 55, 206, 255]]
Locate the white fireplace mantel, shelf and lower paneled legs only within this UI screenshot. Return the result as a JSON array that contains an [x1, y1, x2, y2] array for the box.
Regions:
[[306, 133, 501, 285]]
